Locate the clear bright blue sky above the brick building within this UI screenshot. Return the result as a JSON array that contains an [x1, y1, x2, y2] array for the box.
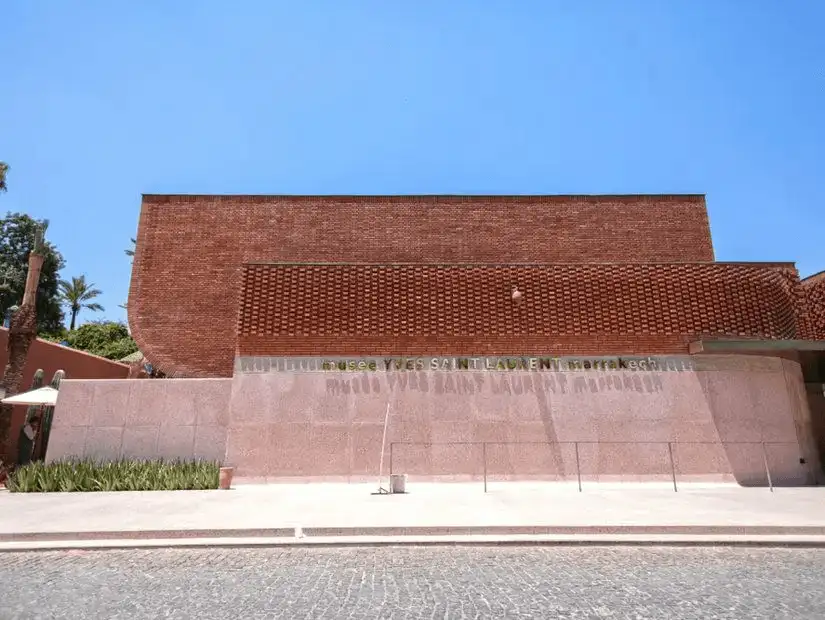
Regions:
[[0, 0, 825, 330]]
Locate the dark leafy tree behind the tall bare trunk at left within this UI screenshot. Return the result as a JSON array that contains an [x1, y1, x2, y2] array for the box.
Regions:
[[0, 213, 65, 335]]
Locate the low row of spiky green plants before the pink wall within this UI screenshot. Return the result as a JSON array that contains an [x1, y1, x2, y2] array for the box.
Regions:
[[6, 459, 220, 493]]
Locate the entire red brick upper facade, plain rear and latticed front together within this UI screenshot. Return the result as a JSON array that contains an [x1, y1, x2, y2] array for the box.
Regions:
[[129, 196, 808, 376]]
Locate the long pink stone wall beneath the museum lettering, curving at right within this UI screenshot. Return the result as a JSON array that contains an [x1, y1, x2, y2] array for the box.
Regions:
[[226, 356, 818, 485]]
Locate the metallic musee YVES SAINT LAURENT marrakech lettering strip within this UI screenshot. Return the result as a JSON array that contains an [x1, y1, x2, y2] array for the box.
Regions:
[[237, 356, 694, 372]]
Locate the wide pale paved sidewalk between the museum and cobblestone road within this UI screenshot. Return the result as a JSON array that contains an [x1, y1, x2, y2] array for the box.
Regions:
[[0, 482, 825, 548]]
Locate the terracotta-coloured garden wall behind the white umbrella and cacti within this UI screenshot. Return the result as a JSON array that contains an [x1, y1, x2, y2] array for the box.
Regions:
[[0, 328, 129, 458]]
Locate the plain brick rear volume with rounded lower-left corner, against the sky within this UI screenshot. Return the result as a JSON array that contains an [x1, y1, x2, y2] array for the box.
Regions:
[[129, 196, 713, 376]]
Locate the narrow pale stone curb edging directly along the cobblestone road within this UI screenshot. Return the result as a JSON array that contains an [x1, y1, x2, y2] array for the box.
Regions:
[[0, 534, 825, 553]]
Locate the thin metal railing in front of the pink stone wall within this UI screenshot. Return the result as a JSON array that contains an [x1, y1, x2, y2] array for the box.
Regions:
[[389, 441, 803, 493]]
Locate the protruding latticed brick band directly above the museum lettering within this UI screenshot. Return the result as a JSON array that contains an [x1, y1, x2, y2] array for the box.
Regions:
[[238, 263, 799, 356]]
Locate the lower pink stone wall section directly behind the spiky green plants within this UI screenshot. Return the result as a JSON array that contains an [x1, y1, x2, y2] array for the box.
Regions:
[[46, 379, 231, 461]]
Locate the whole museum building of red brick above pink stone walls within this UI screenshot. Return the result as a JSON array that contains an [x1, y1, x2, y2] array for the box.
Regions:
[[49, 195, 825, 484]]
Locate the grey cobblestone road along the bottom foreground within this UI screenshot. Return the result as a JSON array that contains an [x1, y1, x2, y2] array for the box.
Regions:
[[0, 547, 825, 620]]
